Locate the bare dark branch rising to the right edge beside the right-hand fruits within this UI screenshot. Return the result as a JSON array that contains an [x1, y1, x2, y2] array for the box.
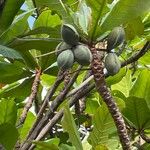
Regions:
[[121, 41, 150, 67]]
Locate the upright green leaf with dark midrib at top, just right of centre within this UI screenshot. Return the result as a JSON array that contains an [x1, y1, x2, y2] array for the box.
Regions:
[[86, 0, 109, 40]]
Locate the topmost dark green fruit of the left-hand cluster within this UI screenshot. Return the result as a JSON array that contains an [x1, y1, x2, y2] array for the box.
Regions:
[[61, 24, 79, 46]]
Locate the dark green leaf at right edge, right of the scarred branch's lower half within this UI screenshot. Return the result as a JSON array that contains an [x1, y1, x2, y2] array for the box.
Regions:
[[123, 97, 150, 131]]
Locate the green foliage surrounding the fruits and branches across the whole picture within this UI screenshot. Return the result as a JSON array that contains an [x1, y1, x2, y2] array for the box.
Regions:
[[0, 0, 150, 150]]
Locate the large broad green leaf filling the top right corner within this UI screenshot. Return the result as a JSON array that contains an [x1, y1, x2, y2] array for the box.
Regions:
[[101, 0, 150, 32]]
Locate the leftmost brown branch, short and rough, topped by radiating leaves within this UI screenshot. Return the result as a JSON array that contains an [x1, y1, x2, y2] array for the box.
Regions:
[[17, 70, 41, 126]]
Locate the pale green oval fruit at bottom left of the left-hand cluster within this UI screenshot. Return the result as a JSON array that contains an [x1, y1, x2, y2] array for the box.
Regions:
[[57, 50, 74, 70]]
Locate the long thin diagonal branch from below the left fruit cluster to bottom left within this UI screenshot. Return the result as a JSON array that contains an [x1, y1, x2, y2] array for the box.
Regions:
[[22, 66, 82, 150]]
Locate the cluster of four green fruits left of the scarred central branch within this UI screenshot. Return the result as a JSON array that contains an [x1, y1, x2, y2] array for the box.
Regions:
[[56, 24, 92, 70]]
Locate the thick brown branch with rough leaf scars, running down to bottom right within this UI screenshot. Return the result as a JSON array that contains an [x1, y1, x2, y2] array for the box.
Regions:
[[91, 48, 131, 150]]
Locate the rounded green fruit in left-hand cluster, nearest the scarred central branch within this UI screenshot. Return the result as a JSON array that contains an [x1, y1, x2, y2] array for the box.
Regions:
[[73, 45, 92, 66]]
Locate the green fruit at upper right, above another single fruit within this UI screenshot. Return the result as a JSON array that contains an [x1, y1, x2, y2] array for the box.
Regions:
[[107, 27, 125, 51]]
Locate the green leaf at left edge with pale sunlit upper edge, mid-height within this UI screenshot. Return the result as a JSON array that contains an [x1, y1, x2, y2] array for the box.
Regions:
[[0, 78, 33, 103]]
